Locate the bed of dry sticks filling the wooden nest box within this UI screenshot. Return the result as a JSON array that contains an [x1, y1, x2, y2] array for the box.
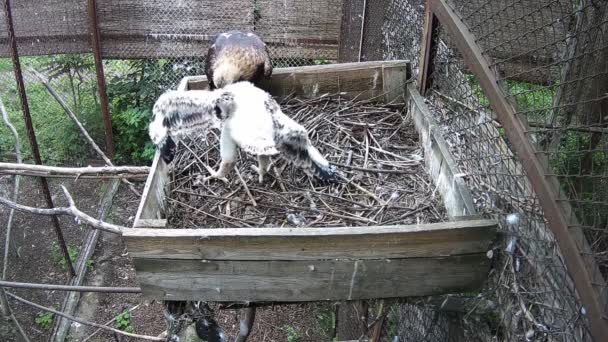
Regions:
[[166, 95, 445, 228]]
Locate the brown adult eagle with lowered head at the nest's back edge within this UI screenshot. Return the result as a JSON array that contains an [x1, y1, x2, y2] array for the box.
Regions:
[[205, 31, 272, 90]]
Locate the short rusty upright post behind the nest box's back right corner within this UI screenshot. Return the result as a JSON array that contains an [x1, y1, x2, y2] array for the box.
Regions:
[[418, 0, 439, 96]]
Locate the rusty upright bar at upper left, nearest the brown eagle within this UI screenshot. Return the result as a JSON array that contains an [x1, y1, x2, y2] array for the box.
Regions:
[[87, 0, 114, 159]]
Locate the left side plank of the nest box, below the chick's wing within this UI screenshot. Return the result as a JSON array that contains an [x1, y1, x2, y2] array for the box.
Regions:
[[133, 151, 169, 227]]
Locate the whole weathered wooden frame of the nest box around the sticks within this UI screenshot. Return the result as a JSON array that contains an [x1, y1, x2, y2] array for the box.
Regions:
[[124, 61, 496, 302]]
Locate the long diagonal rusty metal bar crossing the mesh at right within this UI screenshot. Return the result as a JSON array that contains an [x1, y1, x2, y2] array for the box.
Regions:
[[429, 0, 608, 341]]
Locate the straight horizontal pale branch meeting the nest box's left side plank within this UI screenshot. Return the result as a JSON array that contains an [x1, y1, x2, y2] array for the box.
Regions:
[[0, 163, 150, 179]]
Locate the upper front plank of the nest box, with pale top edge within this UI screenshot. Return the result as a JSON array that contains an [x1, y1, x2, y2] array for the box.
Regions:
[[123, 220, 496, 260]]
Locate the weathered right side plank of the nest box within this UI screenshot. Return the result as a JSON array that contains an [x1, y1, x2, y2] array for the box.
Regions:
[[407, 84, 478, 219]]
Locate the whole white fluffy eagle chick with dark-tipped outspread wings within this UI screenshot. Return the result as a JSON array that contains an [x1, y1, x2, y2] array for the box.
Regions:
[[149, 82, 337, 183]]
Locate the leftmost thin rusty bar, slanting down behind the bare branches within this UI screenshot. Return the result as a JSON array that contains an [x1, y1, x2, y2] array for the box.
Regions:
[[4, 0, 76, 277]]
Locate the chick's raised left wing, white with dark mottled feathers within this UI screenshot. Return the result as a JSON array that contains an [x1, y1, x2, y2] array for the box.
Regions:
[[148, 90, 224, 163]]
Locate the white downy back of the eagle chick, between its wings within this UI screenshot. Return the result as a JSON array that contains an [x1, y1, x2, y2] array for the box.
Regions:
[[224, 82, 279, 155]]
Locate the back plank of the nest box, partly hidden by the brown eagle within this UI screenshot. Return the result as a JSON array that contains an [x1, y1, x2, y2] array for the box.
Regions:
[[183, 60, 409, 101]]
